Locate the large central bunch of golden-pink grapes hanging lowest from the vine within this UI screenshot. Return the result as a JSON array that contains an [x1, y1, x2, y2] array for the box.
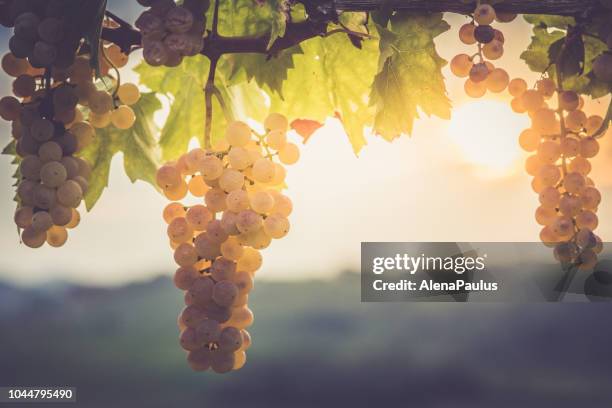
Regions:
[[157, 113, 299, 373]]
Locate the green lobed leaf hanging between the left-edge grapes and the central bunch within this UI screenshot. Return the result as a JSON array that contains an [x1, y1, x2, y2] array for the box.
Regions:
[[79, 93, 161, 211]]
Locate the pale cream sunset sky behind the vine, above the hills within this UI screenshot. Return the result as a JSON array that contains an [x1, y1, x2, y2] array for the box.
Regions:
[[0, 7, 612, 285]]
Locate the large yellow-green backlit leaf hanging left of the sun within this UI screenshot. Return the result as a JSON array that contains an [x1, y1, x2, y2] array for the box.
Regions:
[[370, 12, 451, 140]]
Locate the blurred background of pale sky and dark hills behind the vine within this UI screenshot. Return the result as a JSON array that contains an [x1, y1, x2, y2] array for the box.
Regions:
[[0, 0, 612, 407]]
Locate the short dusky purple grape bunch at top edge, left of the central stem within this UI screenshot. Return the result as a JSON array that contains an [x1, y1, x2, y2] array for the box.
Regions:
[[136, 0, 209, 67]]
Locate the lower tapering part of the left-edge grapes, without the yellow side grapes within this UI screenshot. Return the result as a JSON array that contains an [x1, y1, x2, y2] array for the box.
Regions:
[[0, 67, 93, 248]]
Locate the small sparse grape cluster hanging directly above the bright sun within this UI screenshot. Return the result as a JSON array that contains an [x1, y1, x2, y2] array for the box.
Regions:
[[450, 4, 516, 98]]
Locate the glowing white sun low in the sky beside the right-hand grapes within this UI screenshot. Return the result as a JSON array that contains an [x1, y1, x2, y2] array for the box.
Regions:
[[448, 101, 529, 175]]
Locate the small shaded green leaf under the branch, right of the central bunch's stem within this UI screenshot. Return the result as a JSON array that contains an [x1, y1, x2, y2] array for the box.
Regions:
[[226, 45, 303, 96]]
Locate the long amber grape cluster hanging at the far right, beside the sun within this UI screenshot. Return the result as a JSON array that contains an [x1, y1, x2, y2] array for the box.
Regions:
[[509, 78, 603, 270]]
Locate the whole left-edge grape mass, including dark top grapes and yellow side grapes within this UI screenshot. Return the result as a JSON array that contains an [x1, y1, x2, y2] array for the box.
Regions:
[[0, 0, 140, 248]]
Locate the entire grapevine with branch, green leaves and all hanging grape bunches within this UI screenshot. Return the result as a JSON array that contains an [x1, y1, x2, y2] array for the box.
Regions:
[[0, 0, 612, 373]]
